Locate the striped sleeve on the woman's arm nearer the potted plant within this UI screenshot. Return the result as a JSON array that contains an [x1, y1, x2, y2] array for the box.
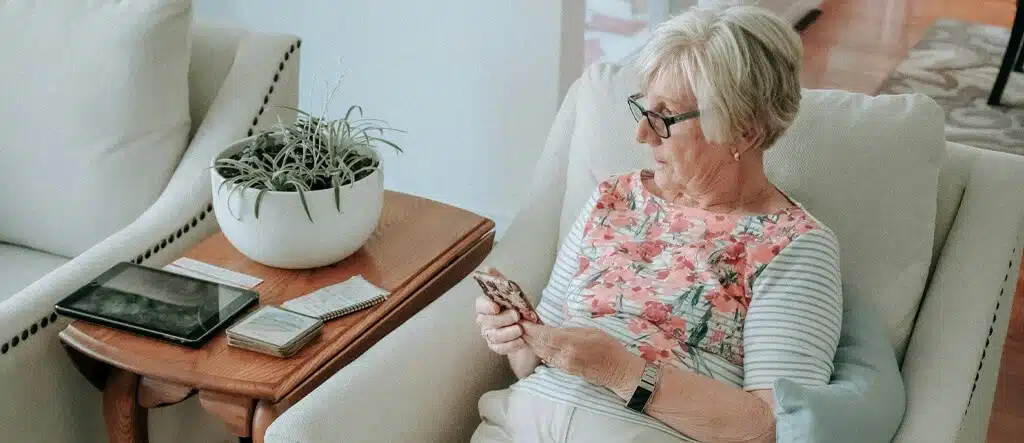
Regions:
[[537, 186, 600, 326]]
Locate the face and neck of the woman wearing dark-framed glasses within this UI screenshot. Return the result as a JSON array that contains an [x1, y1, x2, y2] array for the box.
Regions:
[[637, 77, 734, 196]]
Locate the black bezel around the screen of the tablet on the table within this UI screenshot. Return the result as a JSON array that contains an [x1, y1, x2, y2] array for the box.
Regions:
[[54, 262, 259, 348]]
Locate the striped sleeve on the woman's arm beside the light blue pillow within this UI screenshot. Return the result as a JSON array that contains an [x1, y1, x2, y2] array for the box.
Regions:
[[743, 229, 843, 391]]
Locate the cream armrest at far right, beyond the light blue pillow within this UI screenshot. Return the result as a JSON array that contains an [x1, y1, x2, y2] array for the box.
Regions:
[[894, 146, 1024, 437]]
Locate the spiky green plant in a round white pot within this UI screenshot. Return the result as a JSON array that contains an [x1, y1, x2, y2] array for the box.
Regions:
[[210, 91, 401, 269]]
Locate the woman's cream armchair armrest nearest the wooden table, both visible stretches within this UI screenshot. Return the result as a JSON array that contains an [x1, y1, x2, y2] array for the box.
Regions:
[[265, 72, 575, 443]]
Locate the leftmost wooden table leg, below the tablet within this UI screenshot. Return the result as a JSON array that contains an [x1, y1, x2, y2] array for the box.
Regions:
[[103, 368, 150, 443]]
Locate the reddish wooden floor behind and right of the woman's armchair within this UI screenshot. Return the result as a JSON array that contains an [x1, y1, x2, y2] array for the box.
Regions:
[[802, 0, 1024, 437]]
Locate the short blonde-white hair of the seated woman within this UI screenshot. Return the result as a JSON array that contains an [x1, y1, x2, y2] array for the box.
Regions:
[[636, 6, 803, 148]]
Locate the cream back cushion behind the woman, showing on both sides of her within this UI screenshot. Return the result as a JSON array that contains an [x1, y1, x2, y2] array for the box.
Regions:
[[561, 64, 945, 360]]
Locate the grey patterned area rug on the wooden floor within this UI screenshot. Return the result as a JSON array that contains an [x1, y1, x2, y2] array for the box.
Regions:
[[879, 19, 1024, 156]]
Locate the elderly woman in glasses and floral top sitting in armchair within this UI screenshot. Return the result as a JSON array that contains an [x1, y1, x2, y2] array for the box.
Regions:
[[473, 6, 842, 442]]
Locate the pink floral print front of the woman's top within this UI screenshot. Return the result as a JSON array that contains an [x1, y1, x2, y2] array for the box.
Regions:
[[564, 171, 818, 373]]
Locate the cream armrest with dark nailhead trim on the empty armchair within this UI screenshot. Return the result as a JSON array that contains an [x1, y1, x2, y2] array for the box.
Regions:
[[0, 28, 298, 442]]
